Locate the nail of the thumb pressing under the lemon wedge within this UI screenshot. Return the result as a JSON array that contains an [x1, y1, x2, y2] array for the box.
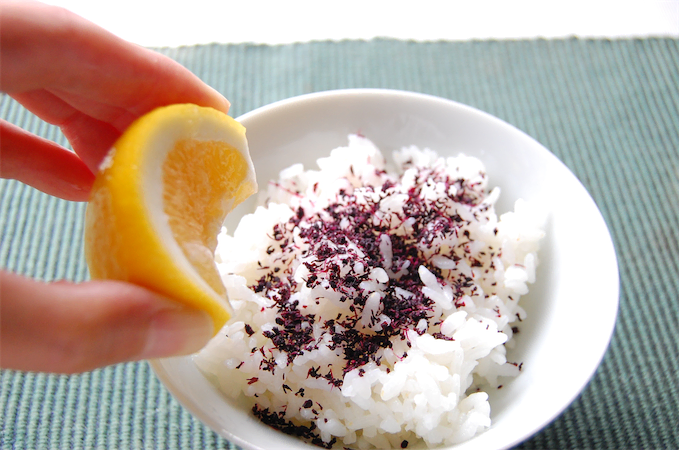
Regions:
[[141, 309, 214, 359]]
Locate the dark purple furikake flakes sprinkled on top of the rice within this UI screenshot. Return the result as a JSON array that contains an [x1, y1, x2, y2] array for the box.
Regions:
[[250, 154, 490, 380]]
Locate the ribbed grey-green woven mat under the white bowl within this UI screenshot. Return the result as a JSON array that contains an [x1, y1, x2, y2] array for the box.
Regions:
[[0, 39, 679, 449]]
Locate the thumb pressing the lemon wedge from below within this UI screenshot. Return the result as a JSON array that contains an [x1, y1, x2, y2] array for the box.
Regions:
[[0, 272, 213, 373]]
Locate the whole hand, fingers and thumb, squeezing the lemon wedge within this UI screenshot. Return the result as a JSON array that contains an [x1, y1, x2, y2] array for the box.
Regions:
[[0, 1, 229, 373]]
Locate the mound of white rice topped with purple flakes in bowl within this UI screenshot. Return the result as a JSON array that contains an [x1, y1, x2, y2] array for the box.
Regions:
[[195, 135, 544, 449]]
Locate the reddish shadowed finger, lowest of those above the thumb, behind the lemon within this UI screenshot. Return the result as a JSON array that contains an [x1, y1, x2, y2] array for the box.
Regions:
[[0, 120, 94, 201]]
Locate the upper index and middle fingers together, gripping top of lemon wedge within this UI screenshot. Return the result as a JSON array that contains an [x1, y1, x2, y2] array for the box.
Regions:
[[0, 2, 229, 170]]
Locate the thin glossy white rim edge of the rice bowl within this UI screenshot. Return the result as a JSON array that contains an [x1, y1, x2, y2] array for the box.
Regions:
[[150, 88, 620, 449]]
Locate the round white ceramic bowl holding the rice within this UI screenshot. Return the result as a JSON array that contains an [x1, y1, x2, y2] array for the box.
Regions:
[[152, 89, 618, 450]]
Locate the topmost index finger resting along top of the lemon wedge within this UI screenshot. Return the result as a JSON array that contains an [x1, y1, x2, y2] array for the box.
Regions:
[[0, 2, 229, 118]]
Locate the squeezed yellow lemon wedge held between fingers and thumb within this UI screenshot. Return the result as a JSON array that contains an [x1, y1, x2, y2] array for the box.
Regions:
[[85, 104, 257, 333]]
